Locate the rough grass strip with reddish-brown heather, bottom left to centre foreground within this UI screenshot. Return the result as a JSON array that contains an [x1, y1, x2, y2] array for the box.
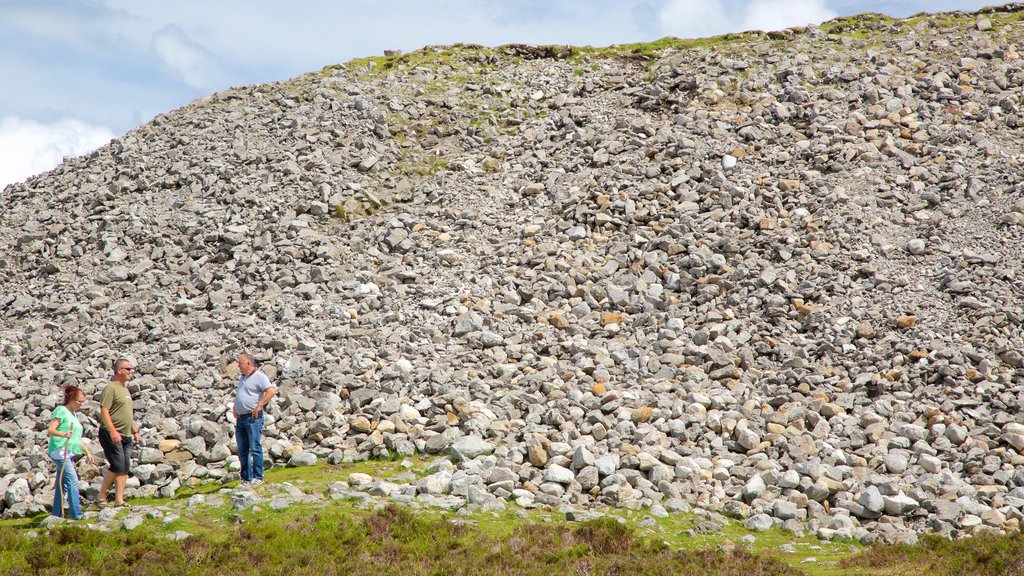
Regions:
[[0, 506, 800, 576]]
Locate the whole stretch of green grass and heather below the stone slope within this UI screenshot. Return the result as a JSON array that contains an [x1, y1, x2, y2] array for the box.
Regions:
[[6, 456, 1024, 576]]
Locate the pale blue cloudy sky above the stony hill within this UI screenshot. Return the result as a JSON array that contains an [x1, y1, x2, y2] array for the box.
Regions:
[[0, 0, 991, 189]]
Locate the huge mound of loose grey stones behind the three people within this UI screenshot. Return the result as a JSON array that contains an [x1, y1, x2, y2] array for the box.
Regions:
[[0, 5, 1024, 540]]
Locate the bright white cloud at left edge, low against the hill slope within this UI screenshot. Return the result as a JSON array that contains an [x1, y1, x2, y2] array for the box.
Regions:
[[0, 116, 115, 190]]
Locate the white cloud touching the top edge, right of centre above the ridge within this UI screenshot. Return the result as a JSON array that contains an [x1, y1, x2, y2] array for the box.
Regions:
[[657, 0, 838, 38]]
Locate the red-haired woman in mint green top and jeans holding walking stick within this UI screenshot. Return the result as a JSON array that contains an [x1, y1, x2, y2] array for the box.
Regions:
[[46, 386, 93, 520]]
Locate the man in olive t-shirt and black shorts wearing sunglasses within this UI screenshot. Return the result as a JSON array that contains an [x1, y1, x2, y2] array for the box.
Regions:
[[99, 358, 141, 506]]
